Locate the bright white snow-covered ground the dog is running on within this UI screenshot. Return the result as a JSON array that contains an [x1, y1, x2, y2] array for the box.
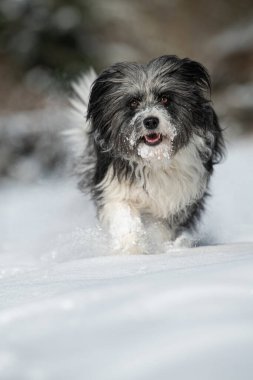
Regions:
[[0, 141, 253, 380]]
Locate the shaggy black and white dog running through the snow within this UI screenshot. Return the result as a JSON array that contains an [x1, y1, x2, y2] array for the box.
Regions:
[[68, 55, 224, 253]]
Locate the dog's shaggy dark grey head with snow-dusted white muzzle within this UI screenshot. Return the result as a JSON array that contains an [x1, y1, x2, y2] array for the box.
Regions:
[[88, 56, 210, 161]]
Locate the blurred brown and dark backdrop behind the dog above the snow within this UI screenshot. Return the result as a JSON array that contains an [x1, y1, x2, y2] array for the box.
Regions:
[[0, 0, 253, 181]]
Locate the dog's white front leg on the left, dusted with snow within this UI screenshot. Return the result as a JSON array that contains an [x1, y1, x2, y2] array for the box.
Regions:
[[99, 202, 145, 254]]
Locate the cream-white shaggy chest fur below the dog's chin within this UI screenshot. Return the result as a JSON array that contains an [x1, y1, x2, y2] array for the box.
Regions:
[[100, 136, 207, 218]]
